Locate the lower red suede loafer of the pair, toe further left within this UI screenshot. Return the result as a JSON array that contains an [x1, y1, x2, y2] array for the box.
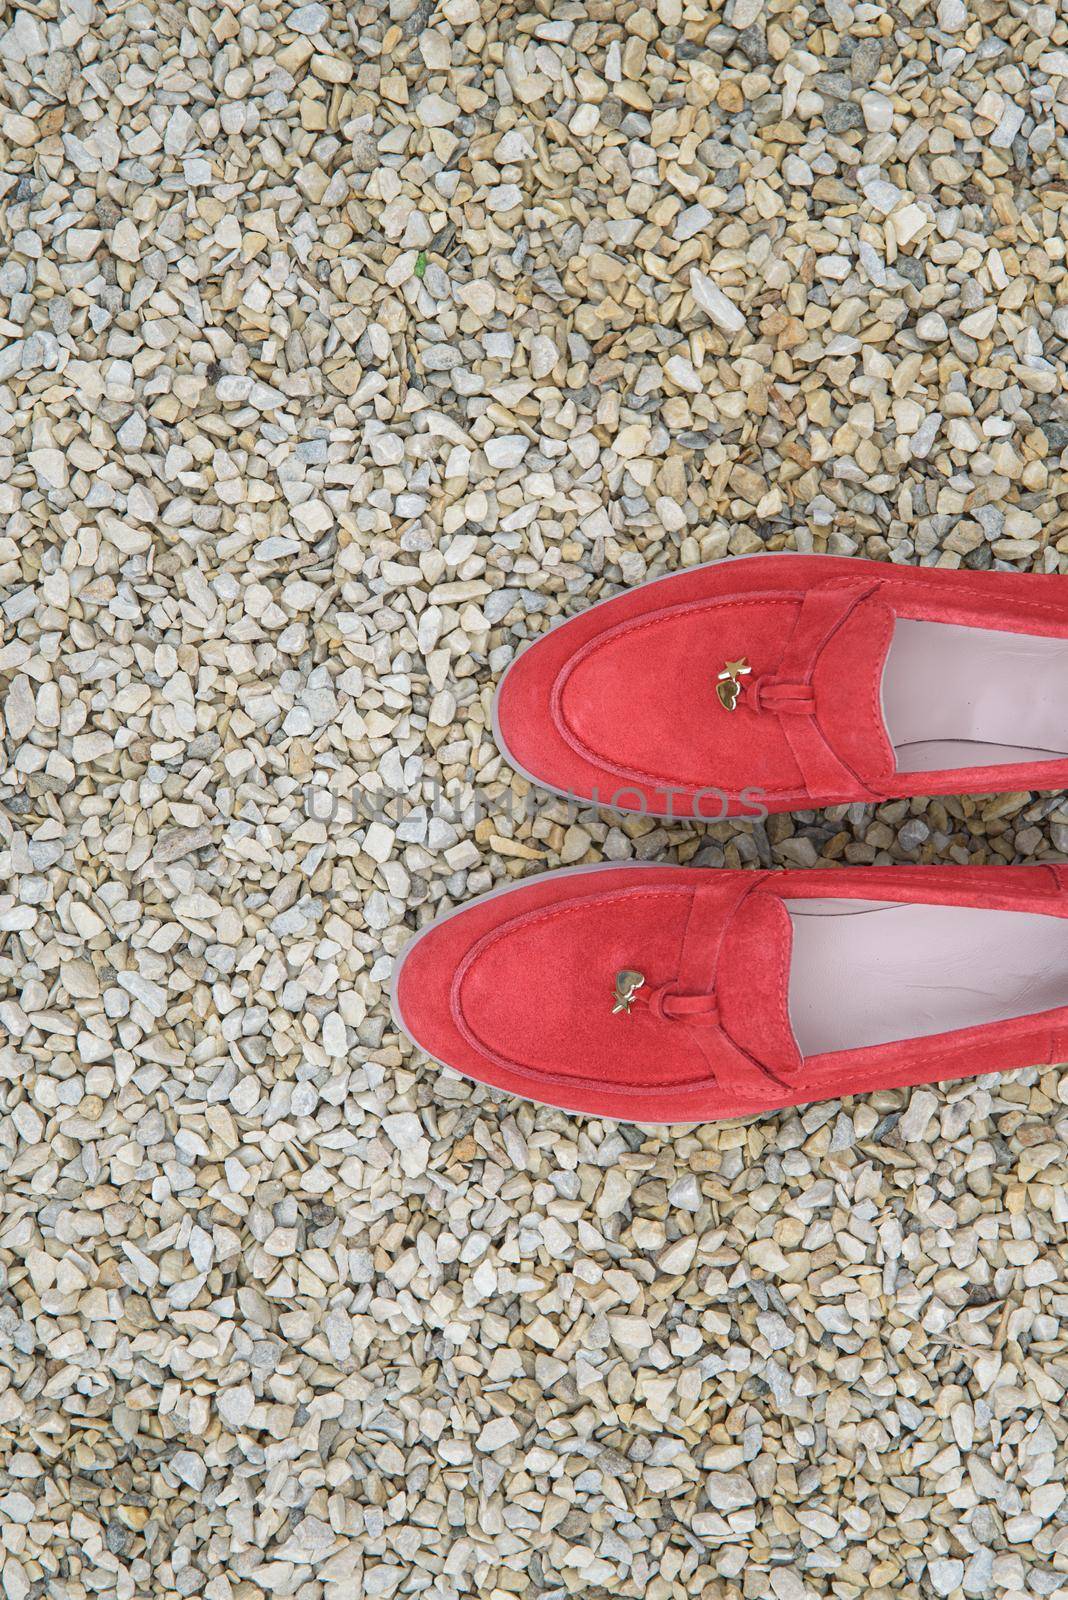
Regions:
[[393, 866, 1068, 1122]]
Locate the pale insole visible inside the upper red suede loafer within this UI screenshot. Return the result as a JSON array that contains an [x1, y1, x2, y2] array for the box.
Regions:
[[883, 619, 1068, 773]]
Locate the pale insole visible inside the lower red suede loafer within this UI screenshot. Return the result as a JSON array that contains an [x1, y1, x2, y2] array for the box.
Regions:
[[787, 899, 1068, 1056]]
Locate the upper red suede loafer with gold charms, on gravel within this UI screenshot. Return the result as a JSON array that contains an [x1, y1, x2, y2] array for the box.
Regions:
[[494, 555, 1068, 819]]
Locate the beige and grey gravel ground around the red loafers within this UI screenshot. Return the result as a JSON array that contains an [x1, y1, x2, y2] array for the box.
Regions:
[[0, 0, 1068, 1600]]
